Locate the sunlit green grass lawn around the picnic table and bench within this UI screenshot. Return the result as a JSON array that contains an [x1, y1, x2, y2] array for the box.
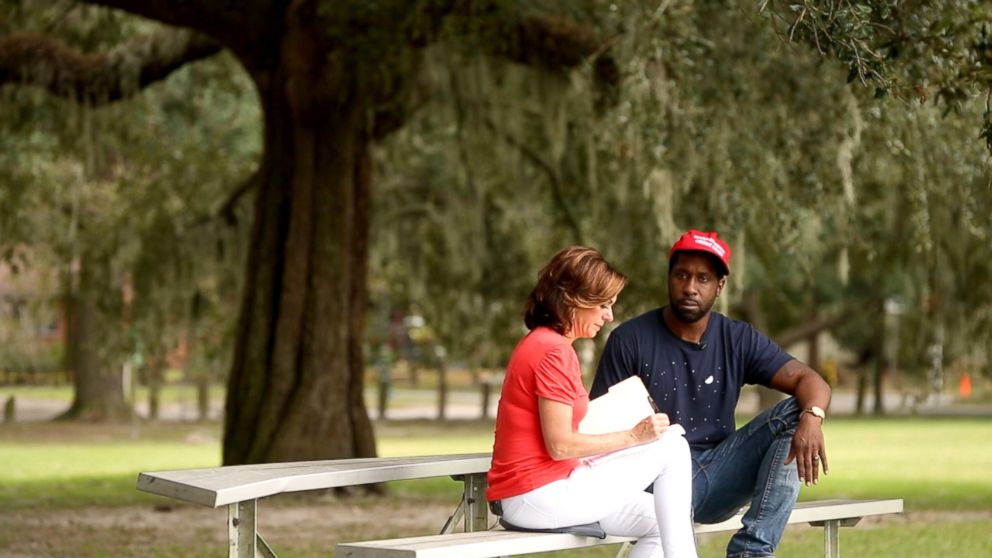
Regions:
[[0, 417, 992, 557]]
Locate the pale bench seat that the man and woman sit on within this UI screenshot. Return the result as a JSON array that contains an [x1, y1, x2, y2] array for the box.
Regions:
[[334, 499, 903, 558]]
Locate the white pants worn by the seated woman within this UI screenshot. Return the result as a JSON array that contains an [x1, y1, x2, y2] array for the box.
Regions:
[[502, 428, 696, 558]]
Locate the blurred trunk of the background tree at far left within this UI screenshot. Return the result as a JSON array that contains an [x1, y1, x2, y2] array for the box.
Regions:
[[59, 260, 131, 422]]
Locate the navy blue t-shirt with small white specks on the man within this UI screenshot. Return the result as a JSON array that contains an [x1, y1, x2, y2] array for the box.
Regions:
[[590, 308, 793, 449]]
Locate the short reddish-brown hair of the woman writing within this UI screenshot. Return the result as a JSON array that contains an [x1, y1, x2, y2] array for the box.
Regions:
[[524, 246, 627, 335]]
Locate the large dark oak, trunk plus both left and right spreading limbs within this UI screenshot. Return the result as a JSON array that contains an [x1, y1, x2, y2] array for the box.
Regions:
[[0, 0, 616, 464]]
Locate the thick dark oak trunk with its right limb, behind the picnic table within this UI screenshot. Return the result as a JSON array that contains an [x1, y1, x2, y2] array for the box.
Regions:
[[208, 0, 619, 464]]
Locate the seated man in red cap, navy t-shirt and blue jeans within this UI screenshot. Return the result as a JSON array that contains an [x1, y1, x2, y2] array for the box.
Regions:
[[590, 230, 830, 558]]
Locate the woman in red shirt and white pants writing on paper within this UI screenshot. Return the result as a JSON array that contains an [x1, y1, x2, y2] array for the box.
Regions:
[[486, 246, 696, 558]]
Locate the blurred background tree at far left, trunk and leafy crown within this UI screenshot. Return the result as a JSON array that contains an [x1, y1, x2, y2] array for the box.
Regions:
[[0, 2, 257, 420]]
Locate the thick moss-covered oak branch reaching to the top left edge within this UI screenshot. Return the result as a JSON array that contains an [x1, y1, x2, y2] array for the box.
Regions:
[[0, 30, 221, 104]]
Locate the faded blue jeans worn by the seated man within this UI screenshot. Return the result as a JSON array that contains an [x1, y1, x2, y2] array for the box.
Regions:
[[692, 397, 800, 558]]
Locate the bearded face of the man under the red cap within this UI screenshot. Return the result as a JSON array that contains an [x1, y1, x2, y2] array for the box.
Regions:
[[668, 252, 727, 324]]
